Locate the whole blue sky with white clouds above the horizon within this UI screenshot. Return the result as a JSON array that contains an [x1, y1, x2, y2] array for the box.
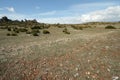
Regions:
[[0, 0, 120, 24]]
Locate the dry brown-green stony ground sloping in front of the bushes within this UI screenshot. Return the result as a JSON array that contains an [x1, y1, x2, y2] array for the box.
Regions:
[[0, 29, 120, 80]]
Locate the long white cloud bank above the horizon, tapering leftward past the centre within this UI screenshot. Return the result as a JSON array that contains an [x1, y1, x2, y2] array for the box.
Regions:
[[39, 6, 120, 23]]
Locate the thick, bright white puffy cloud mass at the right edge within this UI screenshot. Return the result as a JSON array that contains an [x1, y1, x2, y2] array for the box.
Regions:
[[81, 6, 120, 22]]
